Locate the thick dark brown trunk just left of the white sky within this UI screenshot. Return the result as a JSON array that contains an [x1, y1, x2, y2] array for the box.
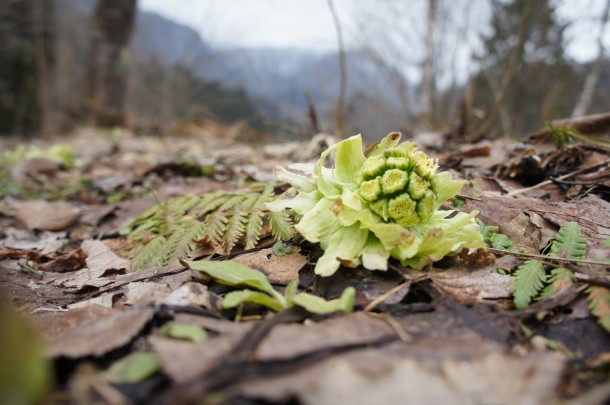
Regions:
[[83, 0, 136, 126]]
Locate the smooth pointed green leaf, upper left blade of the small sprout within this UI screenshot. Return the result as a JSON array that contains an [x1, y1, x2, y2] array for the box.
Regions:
[[181, 260, 277, 295]]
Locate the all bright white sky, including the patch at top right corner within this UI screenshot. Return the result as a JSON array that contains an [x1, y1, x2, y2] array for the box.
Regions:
[[139, 0, 610, 61]]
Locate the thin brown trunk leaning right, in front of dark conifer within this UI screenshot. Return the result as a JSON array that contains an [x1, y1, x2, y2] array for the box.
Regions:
[[472, 0, 536, 142]]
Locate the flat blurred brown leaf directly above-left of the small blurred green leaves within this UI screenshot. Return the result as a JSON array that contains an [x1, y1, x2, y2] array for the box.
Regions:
[[48, 307, 154, 358]]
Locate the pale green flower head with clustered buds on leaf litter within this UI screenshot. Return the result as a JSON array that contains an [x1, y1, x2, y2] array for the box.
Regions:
[[267, 132, 484, 276]]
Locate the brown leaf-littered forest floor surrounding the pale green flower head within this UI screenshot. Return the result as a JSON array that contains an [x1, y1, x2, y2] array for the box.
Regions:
[[0, 124, 610, 404]]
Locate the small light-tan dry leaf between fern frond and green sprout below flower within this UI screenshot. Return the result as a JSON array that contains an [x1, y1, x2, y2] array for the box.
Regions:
[[233, 249, 307, 285]]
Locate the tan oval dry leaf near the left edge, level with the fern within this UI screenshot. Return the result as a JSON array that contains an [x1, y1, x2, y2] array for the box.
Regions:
[[15, 201, 80, 231]]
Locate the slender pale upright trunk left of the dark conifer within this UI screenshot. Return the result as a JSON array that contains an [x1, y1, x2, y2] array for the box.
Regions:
[[419, 0, 438, 129]]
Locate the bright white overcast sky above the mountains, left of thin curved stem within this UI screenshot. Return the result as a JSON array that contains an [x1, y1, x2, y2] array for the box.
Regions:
[[140, 0, 349, 50]]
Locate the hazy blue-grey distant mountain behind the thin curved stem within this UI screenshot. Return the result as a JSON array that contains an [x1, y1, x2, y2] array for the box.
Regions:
[[188, 48, 414, 133]]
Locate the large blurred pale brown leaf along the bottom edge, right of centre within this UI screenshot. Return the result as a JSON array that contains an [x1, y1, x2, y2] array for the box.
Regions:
[[237, 337, 564, 405]]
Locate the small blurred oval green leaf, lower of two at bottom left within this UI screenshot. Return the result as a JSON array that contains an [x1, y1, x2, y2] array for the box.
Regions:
[[104, 352, 161, 384]]
